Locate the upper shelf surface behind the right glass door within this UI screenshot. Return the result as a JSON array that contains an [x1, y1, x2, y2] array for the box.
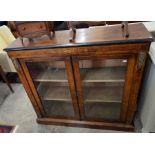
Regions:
[[80, 67, 126, 82]]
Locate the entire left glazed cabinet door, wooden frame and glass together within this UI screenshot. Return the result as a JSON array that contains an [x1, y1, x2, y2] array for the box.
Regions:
[[21, 57, 79, 119]]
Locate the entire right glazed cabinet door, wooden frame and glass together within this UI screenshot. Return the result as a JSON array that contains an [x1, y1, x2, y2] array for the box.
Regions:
[[72, 55, 135, 122]]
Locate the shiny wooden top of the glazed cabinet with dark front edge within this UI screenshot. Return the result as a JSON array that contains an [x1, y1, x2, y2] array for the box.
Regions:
[[4, 23, 153, 52]]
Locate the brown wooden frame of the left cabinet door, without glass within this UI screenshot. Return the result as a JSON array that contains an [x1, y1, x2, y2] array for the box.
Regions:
[[19, 56, 80, 120]]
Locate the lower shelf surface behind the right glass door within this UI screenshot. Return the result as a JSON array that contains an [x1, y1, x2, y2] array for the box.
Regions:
[[84, 87, 123, 103]]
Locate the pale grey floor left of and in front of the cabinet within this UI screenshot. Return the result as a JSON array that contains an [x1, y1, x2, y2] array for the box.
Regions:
[[0, 83, 140, 133]]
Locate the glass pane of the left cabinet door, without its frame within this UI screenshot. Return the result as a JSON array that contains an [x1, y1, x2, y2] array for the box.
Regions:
[[27, 61, 74, 117]]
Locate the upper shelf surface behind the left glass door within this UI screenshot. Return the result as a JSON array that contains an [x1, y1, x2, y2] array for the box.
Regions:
[[32, 69, 68, 82]]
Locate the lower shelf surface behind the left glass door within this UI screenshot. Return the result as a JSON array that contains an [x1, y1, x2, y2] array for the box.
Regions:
[[38, 83, 71, 101]]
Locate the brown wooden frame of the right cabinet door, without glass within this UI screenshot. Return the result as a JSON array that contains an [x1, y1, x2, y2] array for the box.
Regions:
[[72, 53, 136, 123]]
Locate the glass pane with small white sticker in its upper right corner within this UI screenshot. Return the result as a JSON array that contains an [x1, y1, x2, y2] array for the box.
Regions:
[[79, 59, 127, 121]]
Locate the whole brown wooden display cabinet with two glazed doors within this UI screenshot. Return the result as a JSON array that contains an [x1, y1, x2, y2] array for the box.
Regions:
[[5, 24, 152, 131]]
